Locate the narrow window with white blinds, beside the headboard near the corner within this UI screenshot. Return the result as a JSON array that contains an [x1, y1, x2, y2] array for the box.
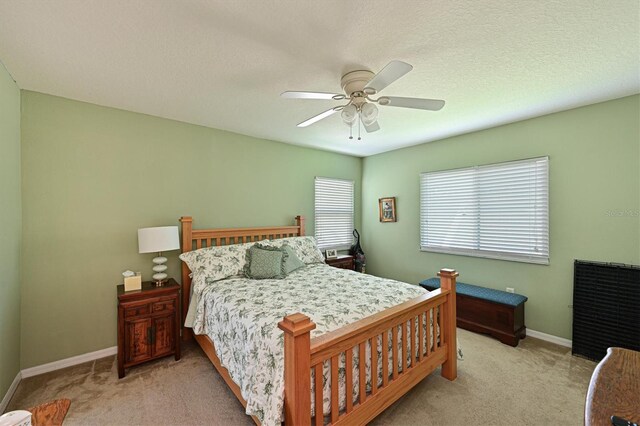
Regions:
[[315, 177, 354, 250]]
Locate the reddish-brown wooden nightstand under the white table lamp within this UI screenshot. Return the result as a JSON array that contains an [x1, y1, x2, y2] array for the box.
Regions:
[[118, 278, 180, 378]]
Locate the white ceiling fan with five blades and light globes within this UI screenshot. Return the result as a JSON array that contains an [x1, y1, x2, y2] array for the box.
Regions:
[[280, 61, 444, 140]]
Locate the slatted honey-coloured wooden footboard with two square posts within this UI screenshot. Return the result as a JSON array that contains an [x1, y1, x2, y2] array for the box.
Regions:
[[278, 269, 458, 426]]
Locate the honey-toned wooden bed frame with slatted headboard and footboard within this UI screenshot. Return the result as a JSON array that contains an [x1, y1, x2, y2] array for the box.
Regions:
[[180, 216, 458, 426]]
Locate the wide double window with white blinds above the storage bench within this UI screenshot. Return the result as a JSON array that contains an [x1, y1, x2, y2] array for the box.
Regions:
[[420, 157, 549, 264]]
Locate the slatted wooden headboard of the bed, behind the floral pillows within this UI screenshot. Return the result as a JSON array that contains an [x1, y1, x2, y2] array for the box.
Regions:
[[180, 216, 304, 340]]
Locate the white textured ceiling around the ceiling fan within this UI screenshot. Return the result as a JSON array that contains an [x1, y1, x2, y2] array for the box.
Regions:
[[0, 0, 640, 156]]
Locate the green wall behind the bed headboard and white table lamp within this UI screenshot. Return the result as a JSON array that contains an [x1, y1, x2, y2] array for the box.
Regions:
[[22, 91, 362, 368]]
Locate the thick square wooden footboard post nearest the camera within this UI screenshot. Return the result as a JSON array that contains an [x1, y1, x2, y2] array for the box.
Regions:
[[278, 313, 322, 426]]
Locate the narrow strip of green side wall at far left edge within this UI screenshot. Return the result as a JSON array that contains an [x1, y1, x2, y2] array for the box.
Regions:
[[0, 63, 22, 400]]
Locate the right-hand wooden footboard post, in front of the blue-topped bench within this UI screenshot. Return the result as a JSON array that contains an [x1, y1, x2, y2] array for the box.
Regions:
[[438, 269, 458, 380]]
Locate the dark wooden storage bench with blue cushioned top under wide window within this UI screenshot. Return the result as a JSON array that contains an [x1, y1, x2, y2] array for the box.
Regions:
[[420, 278, 527, 346]]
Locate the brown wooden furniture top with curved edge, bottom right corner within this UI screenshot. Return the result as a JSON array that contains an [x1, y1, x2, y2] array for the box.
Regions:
[[584, 348, 640, 426]]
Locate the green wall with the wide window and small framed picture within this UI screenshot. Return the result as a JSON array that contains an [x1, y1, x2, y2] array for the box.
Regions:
[[362, 96, 640, 339]]
